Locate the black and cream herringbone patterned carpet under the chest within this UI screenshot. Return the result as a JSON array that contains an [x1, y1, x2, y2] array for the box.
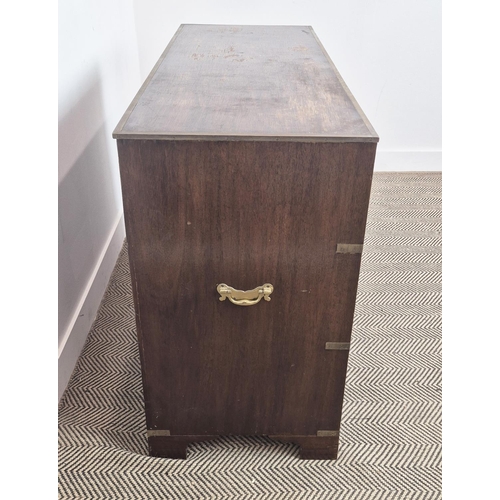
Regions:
[[59, 173, 441, 500]]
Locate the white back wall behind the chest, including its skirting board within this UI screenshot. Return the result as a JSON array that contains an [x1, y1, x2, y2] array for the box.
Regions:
[[134, 0, 441, 170]]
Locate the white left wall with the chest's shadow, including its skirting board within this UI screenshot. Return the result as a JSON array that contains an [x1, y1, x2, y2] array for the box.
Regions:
[[58, 0, 141, 397]]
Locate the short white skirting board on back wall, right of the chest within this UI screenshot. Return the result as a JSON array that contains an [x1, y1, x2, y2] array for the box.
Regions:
[[375, 150, 442, 172]]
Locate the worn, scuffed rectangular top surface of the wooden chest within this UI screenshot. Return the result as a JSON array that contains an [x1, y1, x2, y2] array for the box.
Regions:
[[113, 25, 378, 142]]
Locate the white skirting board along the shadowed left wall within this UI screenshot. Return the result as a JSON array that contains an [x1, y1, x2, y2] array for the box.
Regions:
[[58, 214, 125, 401]]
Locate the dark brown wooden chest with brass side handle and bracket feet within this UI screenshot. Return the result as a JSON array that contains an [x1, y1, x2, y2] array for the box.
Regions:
[[113, 25, 378, 458]]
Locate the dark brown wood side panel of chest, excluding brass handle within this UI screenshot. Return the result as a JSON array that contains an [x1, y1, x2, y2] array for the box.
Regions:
[[118, 140, 376, 440]]
